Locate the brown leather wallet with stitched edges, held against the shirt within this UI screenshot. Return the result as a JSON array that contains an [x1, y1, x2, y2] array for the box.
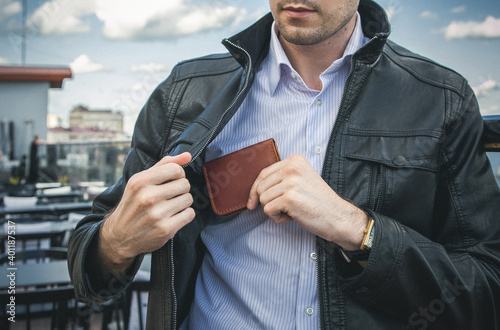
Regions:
[[203, 139, 281, 215]]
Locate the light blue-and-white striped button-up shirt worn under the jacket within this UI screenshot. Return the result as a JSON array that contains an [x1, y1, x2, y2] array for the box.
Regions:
[[182, 15, 367, 330]]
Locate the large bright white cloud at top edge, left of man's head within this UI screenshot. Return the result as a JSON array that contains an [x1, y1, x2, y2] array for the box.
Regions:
[[96, 0, 246, 40]]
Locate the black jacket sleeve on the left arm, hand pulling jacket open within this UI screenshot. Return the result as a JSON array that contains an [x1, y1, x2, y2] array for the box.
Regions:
[[68, 68, 179, 303]]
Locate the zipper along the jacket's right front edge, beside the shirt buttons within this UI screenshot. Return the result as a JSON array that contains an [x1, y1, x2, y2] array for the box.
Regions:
[[316, 36, 378, 330]]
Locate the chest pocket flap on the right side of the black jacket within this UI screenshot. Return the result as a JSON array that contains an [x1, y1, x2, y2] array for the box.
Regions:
[[344, 131, 440, 171]]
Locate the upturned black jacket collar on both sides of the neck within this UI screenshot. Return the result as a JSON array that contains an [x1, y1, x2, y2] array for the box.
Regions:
[[222, 0, 391, 70]]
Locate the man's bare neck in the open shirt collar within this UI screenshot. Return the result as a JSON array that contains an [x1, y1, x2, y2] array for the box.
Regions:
[[279, 15, 357, 91]]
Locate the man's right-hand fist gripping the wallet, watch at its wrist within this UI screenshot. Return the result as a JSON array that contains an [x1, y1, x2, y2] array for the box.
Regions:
[[247, 155, 368, 250]]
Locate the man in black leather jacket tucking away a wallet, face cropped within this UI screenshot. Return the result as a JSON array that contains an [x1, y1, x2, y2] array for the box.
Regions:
[[69, 0, 500, 329]]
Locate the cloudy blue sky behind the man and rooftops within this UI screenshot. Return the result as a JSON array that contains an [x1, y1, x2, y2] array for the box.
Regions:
[[0, 0, 500, 134]]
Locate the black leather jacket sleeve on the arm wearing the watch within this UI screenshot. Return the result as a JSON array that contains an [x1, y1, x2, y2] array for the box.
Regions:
[[338, 86, 500, 329]]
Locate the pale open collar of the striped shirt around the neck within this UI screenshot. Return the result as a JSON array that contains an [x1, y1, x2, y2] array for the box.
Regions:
[[265, 13, 368, 95]]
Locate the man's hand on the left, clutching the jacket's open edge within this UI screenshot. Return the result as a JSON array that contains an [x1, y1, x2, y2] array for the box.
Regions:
[[98, 153, 195, 272]]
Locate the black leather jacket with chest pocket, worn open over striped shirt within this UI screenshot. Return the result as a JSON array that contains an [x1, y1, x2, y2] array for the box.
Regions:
[[69, 0, 500, 329]]
